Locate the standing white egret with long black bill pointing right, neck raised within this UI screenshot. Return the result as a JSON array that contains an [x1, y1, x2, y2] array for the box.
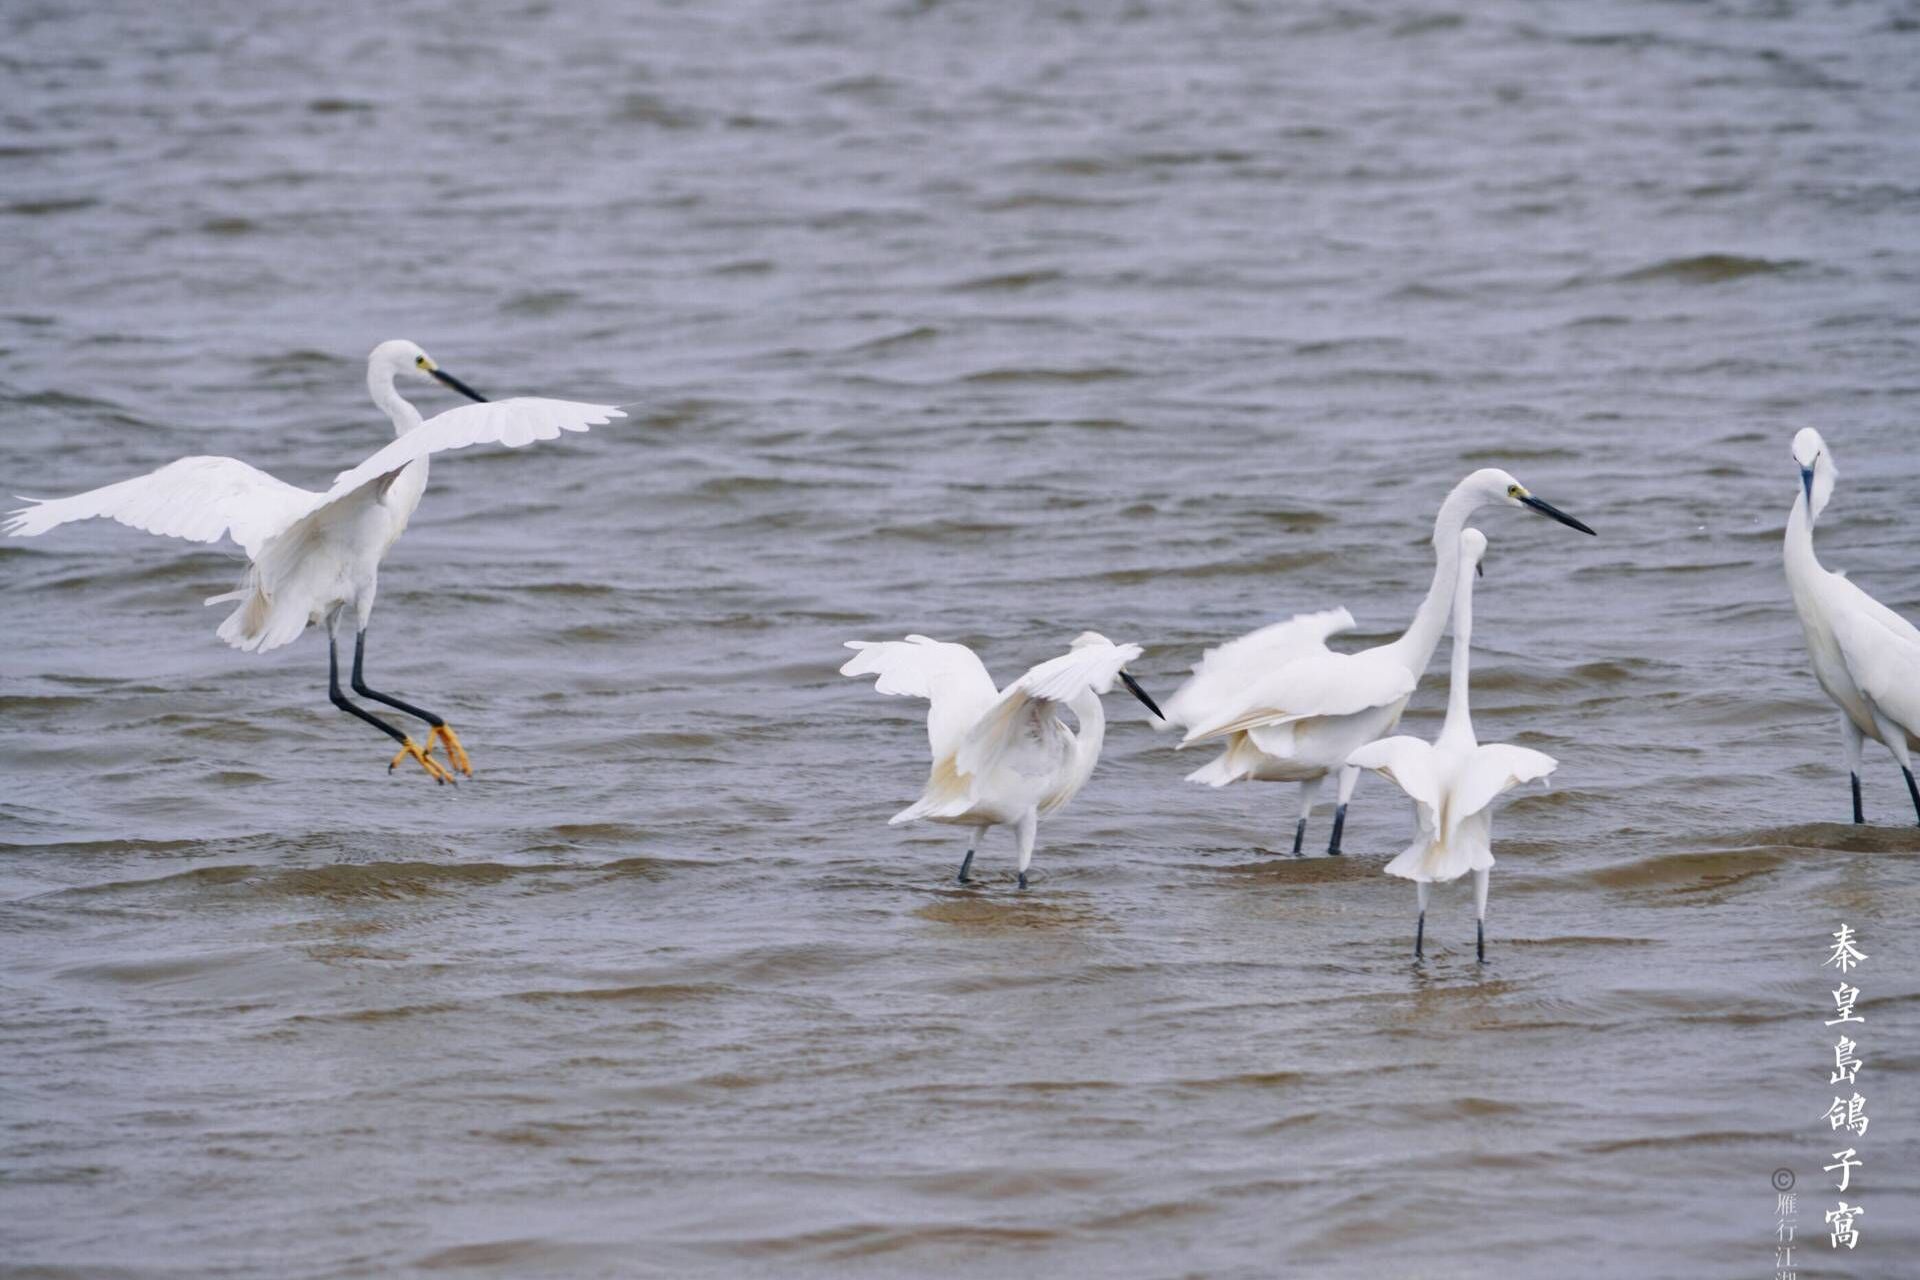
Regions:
[[1167, 466, 1594, 854]]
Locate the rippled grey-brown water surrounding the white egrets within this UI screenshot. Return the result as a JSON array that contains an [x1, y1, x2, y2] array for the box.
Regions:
[[0, 0, 1920, 1278]]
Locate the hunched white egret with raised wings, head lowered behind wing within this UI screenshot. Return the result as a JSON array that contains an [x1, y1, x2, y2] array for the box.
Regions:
[[841, 631, 1160, 889]]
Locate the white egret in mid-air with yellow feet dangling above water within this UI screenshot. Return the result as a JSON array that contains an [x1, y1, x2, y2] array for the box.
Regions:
[[6, 340, 626, 783]]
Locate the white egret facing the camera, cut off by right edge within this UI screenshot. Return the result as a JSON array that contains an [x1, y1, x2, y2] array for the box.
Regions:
[[1786, 426, 1920, 823]]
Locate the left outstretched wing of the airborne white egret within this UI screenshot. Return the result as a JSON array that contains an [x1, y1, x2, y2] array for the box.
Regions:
[[6, 457, 323, 557]]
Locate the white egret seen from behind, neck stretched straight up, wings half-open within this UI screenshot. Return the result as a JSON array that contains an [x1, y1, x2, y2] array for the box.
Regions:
[[1348, 530, 1557, 960]]
